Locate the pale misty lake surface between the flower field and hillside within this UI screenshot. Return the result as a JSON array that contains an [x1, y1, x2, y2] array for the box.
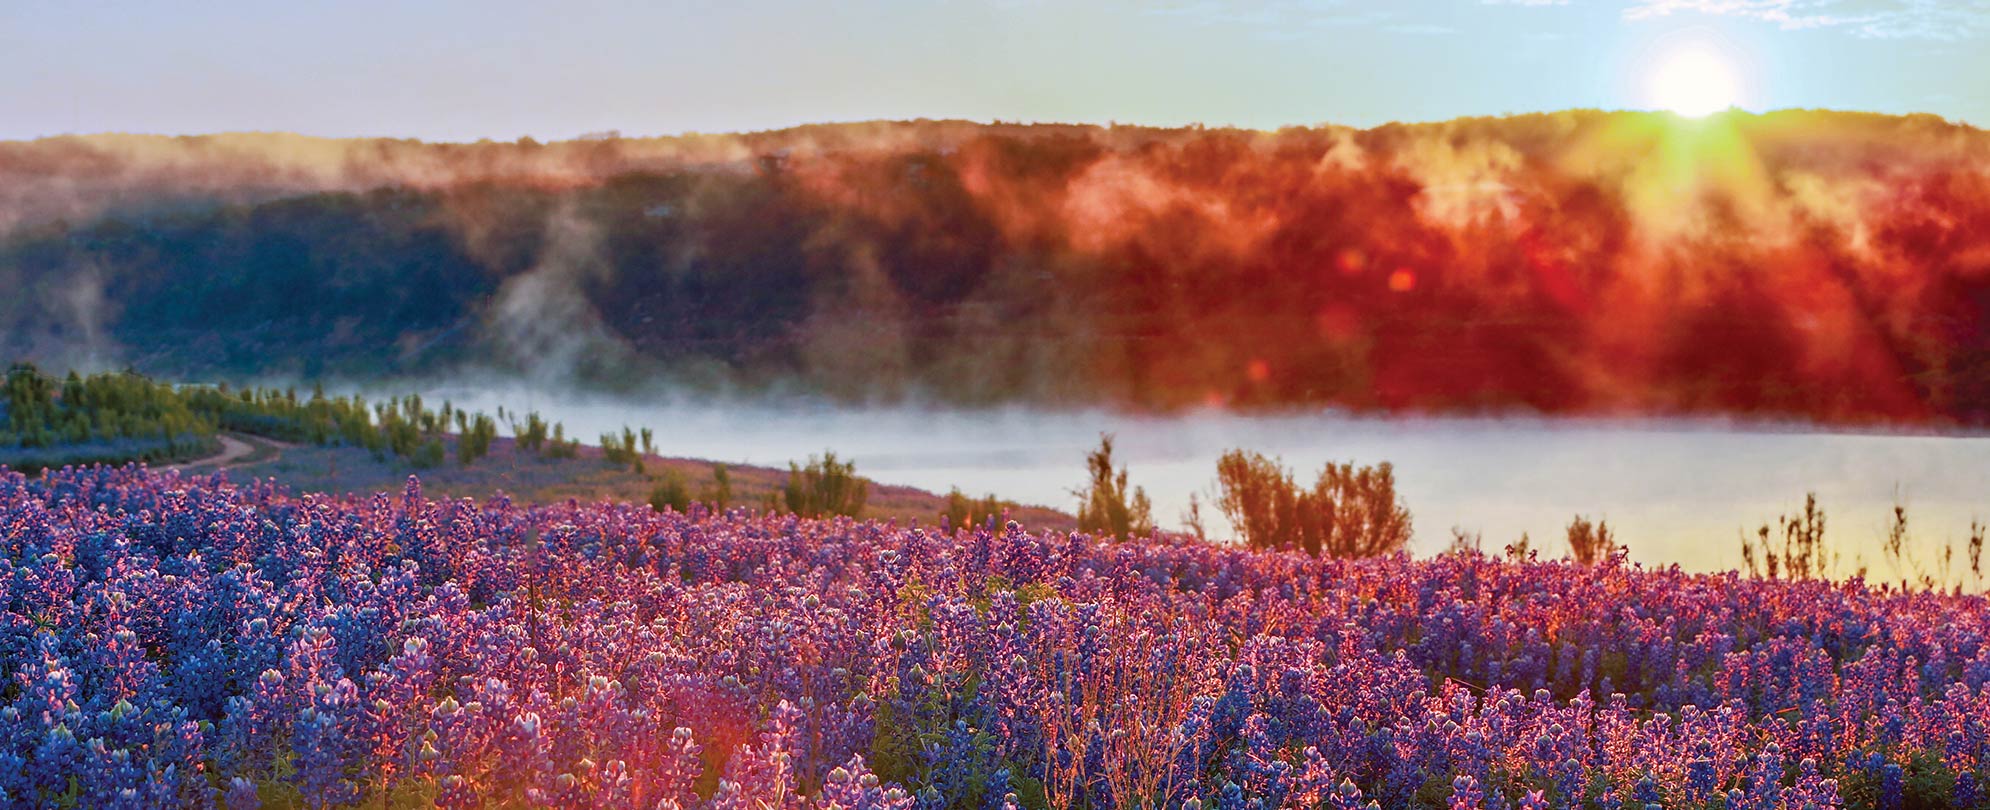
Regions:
[[380, 386, 1990, 573]]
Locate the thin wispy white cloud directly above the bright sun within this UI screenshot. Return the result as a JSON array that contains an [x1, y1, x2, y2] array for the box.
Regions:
[[1615, 0, 1990, 40]]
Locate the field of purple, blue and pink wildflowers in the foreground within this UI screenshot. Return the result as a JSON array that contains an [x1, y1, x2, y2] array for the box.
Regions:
[[0, 468, 1990, 810]]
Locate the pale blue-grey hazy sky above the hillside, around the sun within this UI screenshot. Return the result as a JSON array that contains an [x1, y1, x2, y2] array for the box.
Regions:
[[0, 0, 1990, 139]]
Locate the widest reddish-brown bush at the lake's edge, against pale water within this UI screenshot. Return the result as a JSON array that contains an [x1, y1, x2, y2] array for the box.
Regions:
[[1216, 450, 1409, 557]]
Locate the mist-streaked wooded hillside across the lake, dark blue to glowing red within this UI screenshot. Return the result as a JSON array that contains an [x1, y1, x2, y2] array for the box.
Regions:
[[0, 111, 1990, 424]]
